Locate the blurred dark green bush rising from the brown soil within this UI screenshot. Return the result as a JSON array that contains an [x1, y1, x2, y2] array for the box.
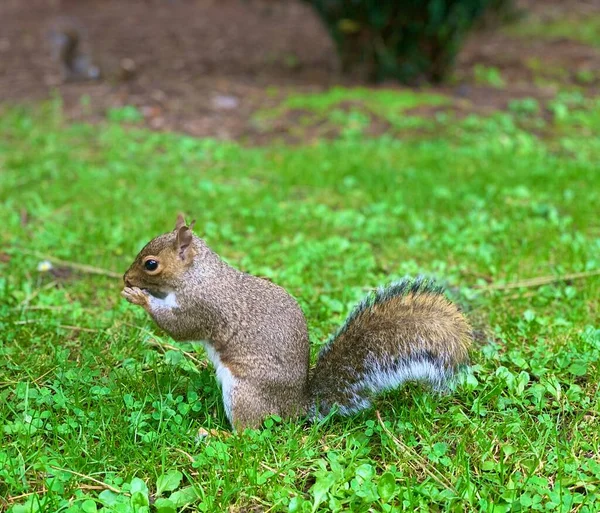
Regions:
[[305, 0, 514, 83]]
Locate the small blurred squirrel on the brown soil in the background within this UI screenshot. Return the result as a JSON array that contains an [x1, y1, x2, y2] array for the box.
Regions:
[[48, 18, 101, 82]]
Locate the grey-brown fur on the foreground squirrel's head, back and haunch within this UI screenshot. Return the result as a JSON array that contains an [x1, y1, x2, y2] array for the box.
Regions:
[[124, 218, 309, 428]]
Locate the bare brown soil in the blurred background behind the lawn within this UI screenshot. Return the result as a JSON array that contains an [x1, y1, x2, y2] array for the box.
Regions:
[[0, 0, 600, 143]]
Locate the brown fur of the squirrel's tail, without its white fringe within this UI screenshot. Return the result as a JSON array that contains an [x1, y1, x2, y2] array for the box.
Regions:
[[311, 293, 471, 413]]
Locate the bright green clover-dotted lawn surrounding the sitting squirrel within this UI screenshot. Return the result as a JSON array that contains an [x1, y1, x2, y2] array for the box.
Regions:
[[0, 93, 600, 513]]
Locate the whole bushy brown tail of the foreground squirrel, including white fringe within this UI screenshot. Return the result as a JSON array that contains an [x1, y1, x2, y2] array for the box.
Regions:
[[310, 278, 472, 416]]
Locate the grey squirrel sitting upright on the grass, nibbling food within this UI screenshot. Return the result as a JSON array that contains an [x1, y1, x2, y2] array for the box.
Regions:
[[122, 215, 472, 430]]
